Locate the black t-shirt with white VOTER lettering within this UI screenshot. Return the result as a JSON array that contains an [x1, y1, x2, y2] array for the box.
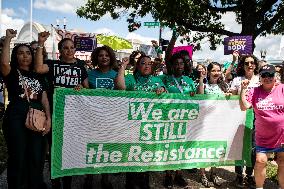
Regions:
[[45, 60, 88, 88]]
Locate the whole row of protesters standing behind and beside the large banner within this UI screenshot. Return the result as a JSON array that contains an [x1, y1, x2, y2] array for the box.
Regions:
[[0, 29, 284, 189]]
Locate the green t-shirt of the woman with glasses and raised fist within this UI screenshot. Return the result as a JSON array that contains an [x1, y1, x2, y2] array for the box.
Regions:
[[125, 73, 165, 92]]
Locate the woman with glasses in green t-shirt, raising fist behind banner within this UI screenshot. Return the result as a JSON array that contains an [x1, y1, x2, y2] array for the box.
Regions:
[[115, 55, 166, 189]]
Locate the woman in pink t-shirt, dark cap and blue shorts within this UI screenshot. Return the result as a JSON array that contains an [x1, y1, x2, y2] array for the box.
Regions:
[[240, 65, 284, 189]]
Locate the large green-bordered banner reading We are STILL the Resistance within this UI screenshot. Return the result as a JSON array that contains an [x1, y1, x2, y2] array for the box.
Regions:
[[51, 89, 252, 178]]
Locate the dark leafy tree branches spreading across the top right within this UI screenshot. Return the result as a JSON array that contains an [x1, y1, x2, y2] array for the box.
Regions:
[[77, 0, 284, 50]]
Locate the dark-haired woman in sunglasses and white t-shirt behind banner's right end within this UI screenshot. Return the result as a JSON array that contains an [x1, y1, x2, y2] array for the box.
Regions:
[[230, 55, 260, 188]]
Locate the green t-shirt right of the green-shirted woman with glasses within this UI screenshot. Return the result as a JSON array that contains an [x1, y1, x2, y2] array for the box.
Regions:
[[160, 75, 196, 94]]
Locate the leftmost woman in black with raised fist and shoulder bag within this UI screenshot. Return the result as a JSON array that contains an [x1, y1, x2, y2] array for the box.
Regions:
[[0, 29, 51, 189]]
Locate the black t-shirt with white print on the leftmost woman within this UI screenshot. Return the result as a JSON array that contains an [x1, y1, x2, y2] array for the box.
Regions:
[[4, 69, 46, 103]]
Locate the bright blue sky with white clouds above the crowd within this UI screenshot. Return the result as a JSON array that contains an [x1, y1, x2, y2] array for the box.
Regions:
[[0, 0, 284, 62]]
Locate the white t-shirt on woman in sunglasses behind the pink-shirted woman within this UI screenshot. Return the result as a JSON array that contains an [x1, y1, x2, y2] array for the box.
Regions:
[[230, 75, 260, 95]]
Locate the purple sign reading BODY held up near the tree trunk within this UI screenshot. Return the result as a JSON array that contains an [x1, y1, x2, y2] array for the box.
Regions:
[[224, 36, 253, 55]]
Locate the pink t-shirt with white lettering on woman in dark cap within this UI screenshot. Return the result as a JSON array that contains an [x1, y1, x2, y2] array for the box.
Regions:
[[247, 84, 284, 148]]
